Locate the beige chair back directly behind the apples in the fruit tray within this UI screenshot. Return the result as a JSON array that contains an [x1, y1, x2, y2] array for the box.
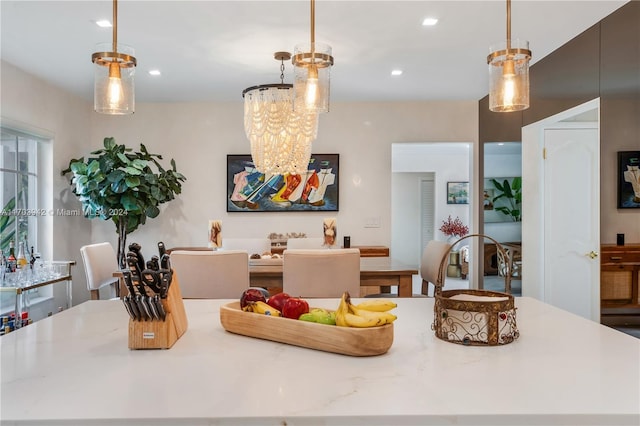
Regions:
[[282, 248, 360, 297]]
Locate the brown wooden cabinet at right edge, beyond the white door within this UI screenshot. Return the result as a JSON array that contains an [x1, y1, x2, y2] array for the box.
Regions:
[[600, 244, 640, 323]]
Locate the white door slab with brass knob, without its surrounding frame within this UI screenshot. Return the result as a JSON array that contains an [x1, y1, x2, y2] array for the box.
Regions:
[[544, 123, 600, 322]]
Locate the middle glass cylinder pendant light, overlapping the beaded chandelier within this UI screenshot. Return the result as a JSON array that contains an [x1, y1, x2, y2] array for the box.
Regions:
[[292, 0, 333, 113]]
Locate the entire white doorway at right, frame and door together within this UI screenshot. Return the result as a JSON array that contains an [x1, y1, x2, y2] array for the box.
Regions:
[[522, 99, 600, 322]]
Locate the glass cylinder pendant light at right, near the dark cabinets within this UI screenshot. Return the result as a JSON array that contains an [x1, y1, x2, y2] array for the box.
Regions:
[[487, 0, 531, 112]]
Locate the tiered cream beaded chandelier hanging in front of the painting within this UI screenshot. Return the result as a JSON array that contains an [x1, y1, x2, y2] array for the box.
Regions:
[[242, 52, 318, 175]]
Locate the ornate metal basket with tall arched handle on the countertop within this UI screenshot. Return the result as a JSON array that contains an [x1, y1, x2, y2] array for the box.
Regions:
[[431, 234, 520, 346]]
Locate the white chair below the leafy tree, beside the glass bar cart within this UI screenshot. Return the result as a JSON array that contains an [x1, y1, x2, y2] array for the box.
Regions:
[[80, 243, 120, 300]]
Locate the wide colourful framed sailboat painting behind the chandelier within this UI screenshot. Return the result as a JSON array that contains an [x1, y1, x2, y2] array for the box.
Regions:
[[227, 154, 340, 212]]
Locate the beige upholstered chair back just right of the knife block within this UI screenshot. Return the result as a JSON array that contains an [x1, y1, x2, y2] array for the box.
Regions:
[[171, 250, 249, 299]]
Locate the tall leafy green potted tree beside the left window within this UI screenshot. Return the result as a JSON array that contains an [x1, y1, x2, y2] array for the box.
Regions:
[[62, 138, 186, 267]]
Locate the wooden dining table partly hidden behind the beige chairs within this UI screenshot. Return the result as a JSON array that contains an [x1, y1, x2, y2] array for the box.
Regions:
[[249, 257, 418, 297]]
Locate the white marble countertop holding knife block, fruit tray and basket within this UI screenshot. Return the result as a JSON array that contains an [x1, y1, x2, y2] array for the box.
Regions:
[[0, 298, 640, 426]]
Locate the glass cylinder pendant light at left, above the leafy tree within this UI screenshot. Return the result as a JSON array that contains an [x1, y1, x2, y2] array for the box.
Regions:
[[91, 0, 137, 115]]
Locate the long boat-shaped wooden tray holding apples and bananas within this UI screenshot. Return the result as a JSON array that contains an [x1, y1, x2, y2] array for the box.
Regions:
[[220, 302, 393, 356]]
